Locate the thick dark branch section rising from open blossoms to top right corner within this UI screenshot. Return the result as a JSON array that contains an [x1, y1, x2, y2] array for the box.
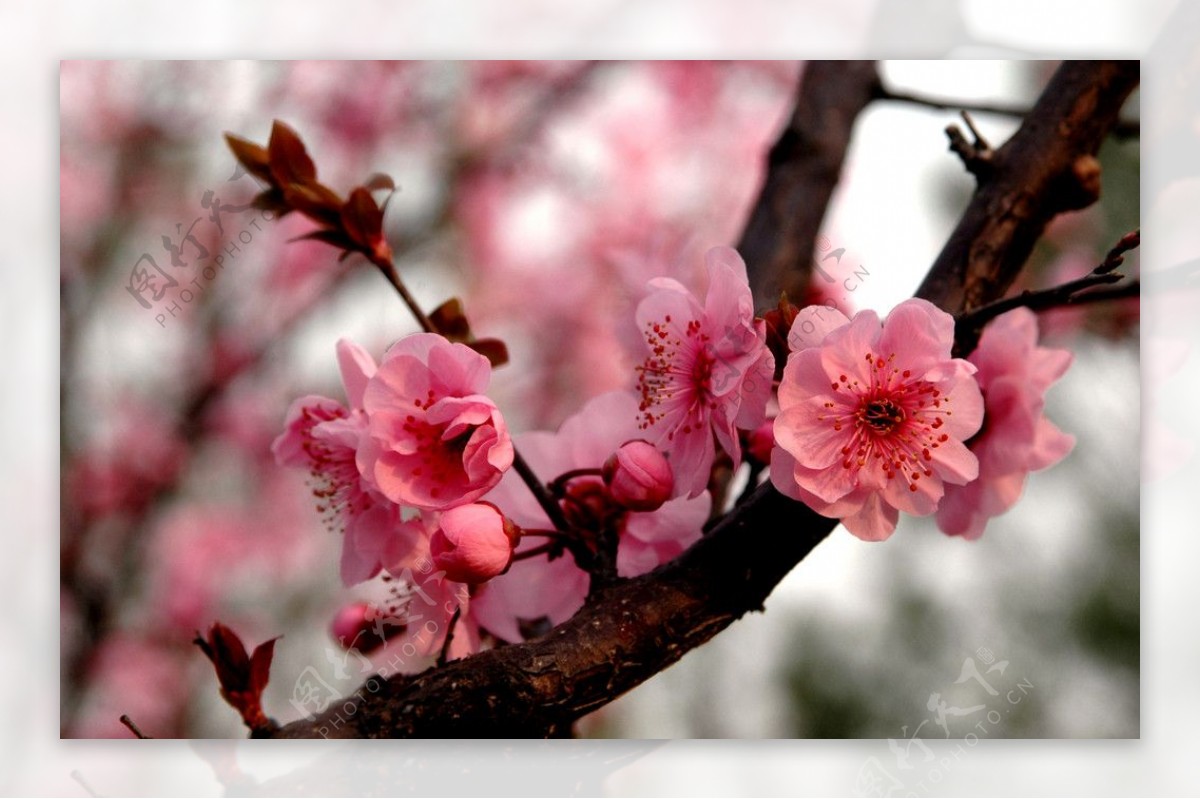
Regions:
[[917, 61, 1139, 313]]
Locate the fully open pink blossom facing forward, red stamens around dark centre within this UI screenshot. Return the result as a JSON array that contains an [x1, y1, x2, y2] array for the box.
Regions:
[[770, 300, 983, 541]]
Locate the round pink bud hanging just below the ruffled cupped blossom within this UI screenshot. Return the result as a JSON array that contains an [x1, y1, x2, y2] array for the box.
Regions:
[[430, 503, 521, 583]]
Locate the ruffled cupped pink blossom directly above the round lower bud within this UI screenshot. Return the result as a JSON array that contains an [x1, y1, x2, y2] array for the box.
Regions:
[[358, 334, 512, 510]]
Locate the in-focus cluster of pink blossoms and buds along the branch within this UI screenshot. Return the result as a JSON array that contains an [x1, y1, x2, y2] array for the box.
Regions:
[[274, 247, 1073, 656]]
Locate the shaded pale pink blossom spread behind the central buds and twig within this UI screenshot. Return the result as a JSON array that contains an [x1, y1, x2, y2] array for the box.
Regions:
[[470, 391, 712, 641]]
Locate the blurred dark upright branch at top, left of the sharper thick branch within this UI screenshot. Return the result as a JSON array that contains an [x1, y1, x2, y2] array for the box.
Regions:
[[738, 61, 878, 307]]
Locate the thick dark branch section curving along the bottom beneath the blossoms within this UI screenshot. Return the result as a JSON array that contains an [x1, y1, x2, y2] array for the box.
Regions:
[[276, 483, 836, 738]]
